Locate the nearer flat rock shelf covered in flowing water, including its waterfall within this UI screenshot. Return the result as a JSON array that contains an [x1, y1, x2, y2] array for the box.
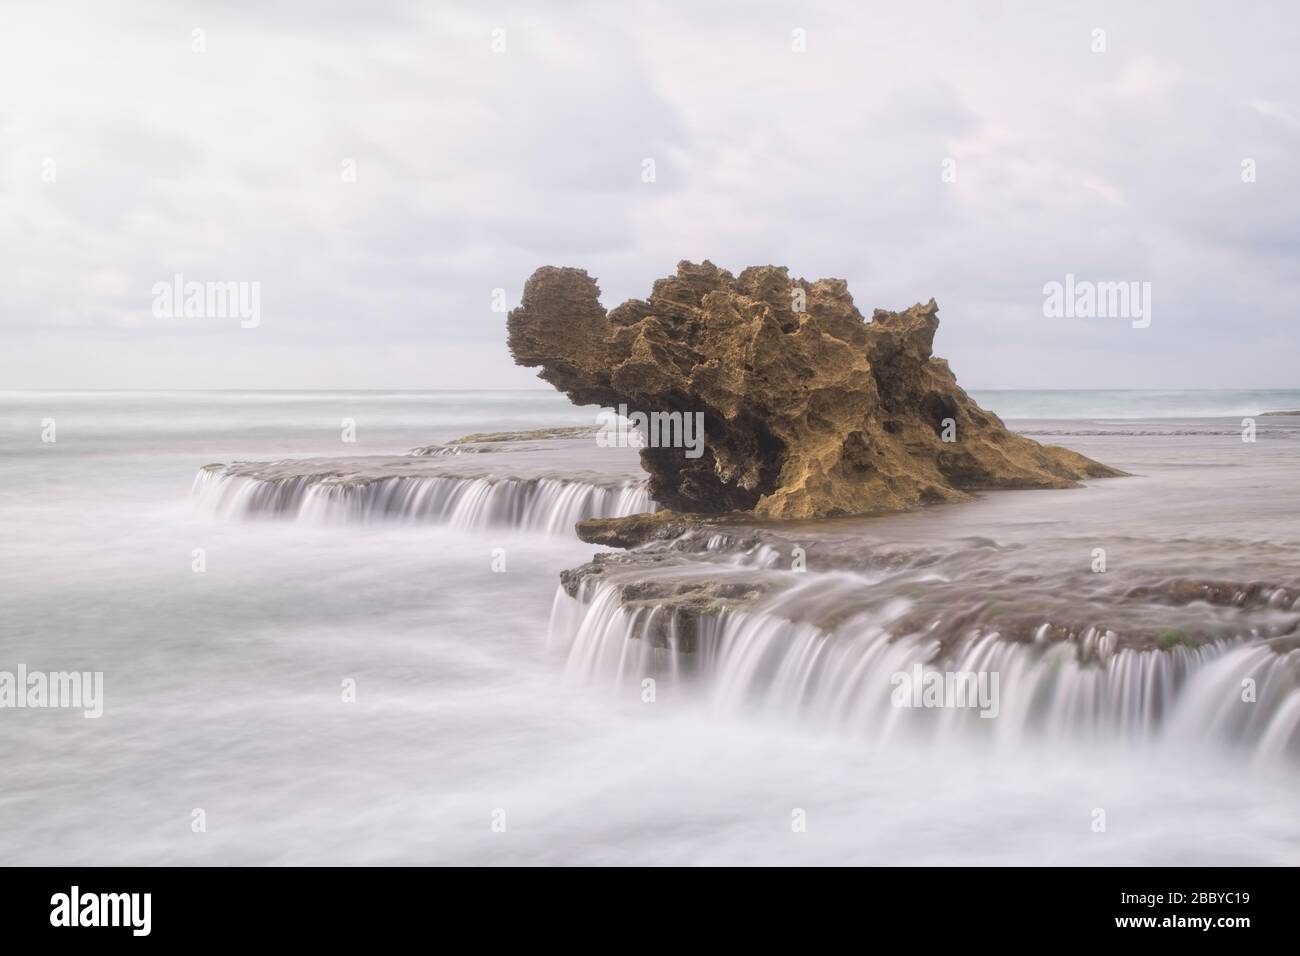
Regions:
[[549, 423, 1300, 765]]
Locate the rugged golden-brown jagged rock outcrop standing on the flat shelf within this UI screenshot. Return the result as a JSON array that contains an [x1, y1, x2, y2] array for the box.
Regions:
[[508, 261, 1122, 518]]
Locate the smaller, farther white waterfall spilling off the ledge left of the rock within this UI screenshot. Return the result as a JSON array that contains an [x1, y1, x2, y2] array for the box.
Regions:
[[192, 467, 657, 533]]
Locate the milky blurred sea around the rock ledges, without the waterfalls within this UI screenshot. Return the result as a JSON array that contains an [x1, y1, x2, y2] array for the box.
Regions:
[[0, 392, 1300, 865]]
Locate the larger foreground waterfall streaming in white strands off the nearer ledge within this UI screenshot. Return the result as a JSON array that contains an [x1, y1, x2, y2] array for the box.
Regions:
[[547, 571, 1300, 757]]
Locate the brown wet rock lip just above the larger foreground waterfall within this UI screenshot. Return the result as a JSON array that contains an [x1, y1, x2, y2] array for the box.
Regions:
[[562, 519, 1300, 663]]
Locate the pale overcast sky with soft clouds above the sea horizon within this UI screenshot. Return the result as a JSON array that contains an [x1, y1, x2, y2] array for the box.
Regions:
[[0, 0, 1300, 389]]
